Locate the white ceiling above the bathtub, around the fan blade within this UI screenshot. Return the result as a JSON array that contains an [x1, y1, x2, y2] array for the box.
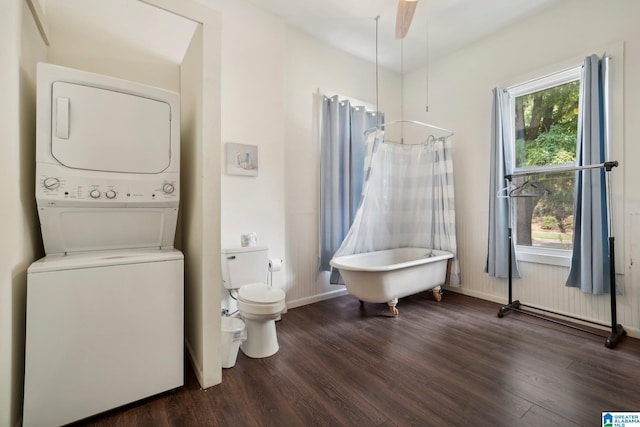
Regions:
[[249, 0, 560, 72]]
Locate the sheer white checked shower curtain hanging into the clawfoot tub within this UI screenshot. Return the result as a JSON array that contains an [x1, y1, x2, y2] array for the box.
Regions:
[[335, 131, 460, 284]]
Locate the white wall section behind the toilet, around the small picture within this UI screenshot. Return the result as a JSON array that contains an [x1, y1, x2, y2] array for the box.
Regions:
[[212, 1, 287, 310]]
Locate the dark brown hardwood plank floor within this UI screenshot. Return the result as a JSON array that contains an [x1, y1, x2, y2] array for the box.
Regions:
[[72, 292, 640, 427]]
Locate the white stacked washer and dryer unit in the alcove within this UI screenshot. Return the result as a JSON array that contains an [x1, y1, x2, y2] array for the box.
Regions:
[[23, 64, 184, 426]]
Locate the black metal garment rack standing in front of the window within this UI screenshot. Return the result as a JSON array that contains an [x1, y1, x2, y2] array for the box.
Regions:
[[498, 161, 627, 349]]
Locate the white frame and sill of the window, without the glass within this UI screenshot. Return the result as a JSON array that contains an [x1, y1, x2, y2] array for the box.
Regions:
[[506, 64, 582, 267]]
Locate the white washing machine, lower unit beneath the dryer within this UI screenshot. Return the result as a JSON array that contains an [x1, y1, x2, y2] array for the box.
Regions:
[[23, 249, 183, 426]]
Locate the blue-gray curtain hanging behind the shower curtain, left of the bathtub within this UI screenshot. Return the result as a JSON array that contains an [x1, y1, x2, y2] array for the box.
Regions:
[[320, 95, 383, 271]]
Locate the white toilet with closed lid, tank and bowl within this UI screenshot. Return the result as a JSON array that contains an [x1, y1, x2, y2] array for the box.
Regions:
[[222, 246, 285, 358]]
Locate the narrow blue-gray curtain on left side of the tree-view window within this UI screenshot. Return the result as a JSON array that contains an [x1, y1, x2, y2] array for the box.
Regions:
[[485, 88, 520, 278]]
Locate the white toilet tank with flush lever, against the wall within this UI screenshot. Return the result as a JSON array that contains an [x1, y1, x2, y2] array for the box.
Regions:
[[222, 246, 269, 289]]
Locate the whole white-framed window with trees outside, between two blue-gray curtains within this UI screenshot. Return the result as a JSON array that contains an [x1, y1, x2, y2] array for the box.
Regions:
[[507, 66, 581, 265]]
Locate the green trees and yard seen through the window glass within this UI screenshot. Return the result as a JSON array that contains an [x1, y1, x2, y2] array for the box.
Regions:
[[513, 79, 580, 249]]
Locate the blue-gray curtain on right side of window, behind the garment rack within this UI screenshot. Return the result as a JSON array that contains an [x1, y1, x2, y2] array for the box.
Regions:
[[567, 55, 611, 295]]
